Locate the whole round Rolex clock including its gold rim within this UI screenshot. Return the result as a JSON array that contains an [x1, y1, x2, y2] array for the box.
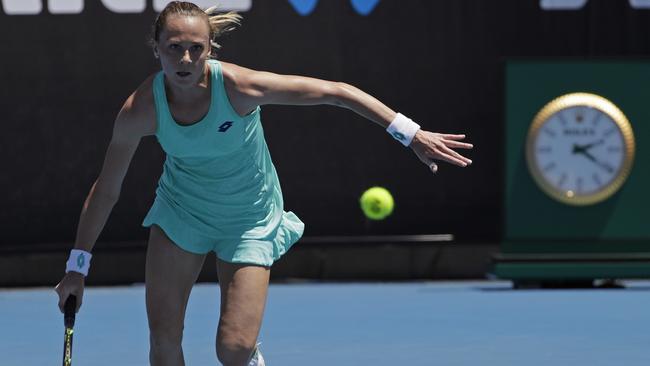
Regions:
[[527, 93, 634, 205]]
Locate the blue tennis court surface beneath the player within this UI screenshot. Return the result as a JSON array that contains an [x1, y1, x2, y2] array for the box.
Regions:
[[0, 281, 650, 366]]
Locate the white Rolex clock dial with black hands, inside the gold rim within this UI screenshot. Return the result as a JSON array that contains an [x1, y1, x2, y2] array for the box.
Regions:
[[532, 106, 625, 199]]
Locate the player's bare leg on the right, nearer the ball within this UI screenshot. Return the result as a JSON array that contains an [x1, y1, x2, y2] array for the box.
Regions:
[[217, 259, 271, 366]]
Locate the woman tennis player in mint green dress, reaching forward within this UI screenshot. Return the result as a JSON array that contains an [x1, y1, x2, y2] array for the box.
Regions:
[[56, 1, 472, 366]]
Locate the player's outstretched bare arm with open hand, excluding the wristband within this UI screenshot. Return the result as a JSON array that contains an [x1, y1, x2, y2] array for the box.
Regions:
[[222, 63, 473, 173]]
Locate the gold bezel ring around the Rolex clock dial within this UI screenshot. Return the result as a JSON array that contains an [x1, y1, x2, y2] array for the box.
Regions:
[[526, 93, 635, 206]]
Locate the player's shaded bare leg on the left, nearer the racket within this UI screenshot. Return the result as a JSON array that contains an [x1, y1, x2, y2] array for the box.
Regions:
[[145, 225, 205, 366]]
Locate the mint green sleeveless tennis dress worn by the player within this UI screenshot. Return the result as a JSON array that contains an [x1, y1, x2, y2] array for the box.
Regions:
[[142, 60, 305, 266]]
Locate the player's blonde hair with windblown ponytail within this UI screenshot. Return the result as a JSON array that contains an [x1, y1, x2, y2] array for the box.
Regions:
[[149, 1, 242, 57]]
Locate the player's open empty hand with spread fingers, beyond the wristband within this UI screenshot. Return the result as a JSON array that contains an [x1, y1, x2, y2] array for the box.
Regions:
[[409, 130, 474, 173]]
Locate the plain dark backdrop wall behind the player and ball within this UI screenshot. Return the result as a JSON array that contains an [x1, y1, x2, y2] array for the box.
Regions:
[[0, 0, 650, 246]]
